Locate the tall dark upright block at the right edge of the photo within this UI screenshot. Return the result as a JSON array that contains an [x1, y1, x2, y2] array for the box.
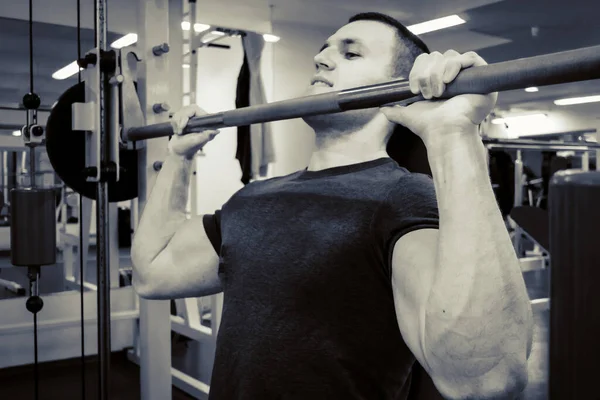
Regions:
[[548, 170, 600, 400]]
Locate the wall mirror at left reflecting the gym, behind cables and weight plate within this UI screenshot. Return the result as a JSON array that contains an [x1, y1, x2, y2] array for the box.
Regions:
[[0, 18, 131, 299]]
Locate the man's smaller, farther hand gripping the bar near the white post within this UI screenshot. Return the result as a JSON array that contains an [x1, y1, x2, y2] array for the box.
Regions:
[[169, 104, 219, 159]]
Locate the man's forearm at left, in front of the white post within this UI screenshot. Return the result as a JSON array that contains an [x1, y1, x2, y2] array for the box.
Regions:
[[132, 154, 192, 269]]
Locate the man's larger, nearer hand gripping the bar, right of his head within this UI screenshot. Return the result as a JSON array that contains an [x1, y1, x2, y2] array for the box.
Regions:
[[381, 50, 498, 148]]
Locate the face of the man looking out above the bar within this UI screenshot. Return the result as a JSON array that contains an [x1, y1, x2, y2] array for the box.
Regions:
[[307, 21, 397, 94]]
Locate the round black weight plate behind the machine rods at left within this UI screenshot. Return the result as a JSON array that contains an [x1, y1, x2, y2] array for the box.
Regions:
[[46, 83, 138, 202]]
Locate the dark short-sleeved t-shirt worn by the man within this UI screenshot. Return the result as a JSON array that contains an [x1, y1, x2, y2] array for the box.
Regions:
[[204, 158, 439, 400]]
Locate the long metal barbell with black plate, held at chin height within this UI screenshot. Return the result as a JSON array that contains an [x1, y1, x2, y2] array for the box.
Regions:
[[46, 46, 600, 202]]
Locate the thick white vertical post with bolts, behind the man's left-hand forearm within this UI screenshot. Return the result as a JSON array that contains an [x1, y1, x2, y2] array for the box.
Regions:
[[137, 0, 172, 400]]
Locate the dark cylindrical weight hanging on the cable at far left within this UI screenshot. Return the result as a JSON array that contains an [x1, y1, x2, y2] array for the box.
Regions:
[[10, 188, 56, 267]]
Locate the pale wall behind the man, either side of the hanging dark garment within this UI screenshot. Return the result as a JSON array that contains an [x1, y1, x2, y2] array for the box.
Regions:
[[190, 19, 332, 213]]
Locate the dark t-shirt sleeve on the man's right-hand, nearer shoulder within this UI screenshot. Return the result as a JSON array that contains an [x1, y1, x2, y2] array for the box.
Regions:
[[374, 173, 440, 277]]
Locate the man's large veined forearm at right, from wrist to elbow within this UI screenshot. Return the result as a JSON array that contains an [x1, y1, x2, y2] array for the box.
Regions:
[[425, 131, 531, 390]]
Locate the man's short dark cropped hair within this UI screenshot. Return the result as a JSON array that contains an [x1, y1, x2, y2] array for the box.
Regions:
[[348, 12, 430, 78]]
